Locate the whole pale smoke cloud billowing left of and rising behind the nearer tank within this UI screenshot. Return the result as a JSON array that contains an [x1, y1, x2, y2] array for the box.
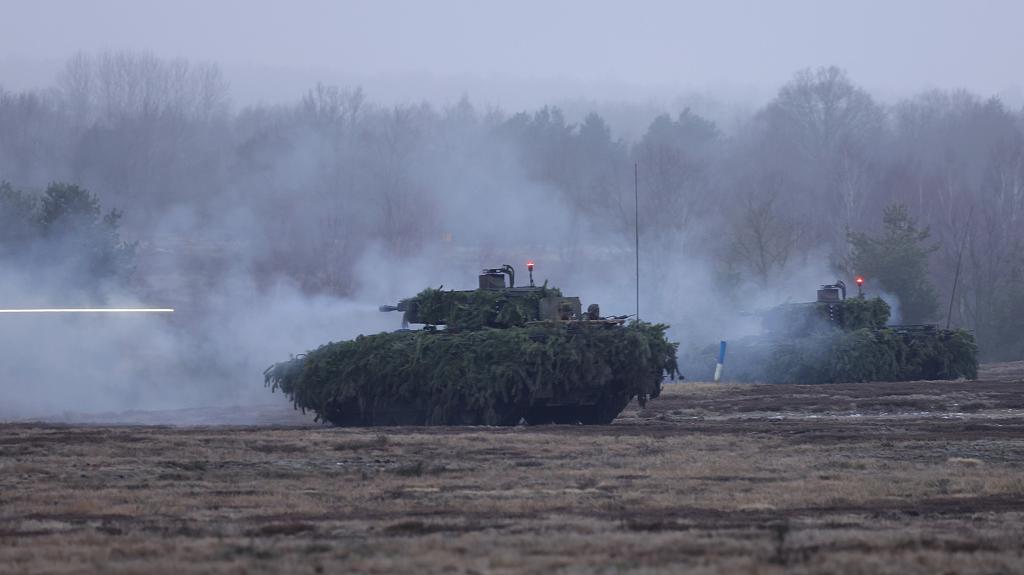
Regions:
[[0, 78, 834, 419]]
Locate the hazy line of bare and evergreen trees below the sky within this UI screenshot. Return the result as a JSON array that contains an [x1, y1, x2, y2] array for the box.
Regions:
[[0, 53, 1024, 358]]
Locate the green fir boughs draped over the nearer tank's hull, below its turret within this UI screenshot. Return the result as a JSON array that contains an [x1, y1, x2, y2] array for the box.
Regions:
[[265, 322, 676, 425]]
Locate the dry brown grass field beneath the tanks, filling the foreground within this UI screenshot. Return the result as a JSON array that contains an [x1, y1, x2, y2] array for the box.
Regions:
[[0, 363, 1024, 574]]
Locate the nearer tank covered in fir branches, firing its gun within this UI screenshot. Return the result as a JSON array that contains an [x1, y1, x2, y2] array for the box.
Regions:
[[264, 264, 678, 426]]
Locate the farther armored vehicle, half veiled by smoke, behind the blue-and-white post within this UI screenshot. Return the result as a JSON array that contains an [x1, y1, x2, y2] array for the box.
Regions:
[[691, 277, 978, 384]]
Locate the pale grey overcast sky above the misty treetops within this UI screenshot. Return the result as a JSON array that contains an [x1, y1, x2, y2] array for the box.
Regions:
[[0, 0, 1024, 105]]
